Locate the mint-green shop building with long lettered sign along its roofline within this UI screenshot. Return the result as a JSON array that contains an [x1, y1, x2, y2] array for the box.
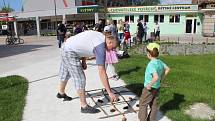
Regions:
[[107, 4, 203, 35]]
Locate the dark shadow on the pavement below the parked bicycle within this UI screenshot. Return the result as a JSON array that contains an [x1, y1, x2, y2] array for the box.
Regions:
[[0, 45, 51, 58]]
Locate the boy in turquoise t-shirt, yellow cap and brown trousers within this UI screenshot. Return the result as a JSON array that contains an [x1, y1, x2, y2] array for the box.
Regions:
[[138, 43, 170, 121]]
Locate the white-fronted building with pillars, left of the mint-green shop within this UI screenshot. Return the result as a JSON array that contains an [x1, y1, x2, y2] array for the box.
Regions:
[[7, 0, 104, 36]]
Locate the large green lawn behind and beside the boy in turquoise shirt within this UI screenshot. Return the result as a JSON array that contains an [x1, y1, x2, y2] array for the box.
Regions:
[[116, 55, 215, 121]]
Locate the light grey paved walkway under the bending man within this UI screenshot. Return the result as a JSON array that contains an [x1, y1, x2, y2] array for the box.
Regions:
[[0, 37, 169, 121]]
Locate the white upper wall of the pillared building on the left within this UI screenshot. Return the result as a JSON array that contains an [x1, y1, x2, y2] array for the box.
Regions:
[[10, 0, 77, 18]]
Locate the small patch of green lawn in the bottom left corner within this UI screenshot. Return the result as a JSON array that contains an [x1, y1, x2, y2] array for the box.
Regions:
[[0, 76, 28, 121]]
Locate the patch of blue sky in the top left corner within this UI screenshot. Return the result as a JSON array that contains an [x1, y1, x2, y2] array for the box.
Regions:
[[0, 0, 22, 11]]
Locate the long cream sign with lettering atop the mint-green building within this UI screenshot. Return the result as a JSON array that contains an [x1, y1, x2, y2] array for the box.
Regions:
[[108, 5, 198, 13]]
